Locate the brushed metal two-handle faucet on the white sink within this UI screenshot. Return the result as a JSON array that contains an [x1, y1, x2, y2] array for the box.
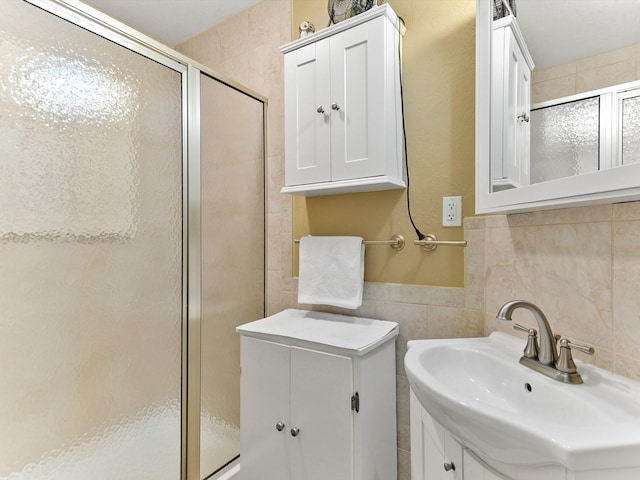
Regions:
[[496, 300, 594, 383]]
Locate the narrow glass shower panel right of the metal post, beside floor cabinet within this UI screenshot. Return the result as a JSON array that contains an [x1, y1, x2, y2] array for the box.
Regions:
[[200, 74, 265, 478]]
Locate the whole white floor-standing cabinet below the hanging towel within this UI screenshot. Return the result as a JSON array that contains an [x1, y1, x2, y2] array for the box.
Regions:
[[237, 310, 398, 480]]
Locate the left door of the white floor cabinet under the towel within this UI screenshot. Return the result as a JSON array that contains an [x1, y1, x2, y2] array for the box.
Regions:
[[240, 336, 295, 480]]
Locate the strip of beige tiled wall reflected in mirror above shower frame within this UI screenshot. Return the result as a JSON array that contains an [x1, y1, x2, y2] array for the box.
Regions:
[[531, 44, 640, 103]]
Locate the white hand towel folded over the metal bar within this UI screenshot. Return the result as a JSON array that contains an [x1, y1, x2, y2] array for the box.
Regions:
[[298, 236, 364, 310]]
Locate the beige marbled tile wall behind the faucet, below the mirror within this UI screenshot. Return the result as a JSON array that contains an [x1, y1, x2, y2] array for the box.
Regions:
[[465, 202, 640, 380]]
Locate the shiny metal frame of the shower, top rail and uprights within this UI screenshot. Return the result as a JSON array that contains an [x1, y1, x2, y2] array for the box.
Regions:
[[23, 0, 268, 480]]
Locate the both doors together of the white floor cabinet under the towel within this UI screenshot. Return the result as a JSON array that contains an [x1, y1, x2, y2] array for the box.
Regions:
[[240, 337, 354, 480]]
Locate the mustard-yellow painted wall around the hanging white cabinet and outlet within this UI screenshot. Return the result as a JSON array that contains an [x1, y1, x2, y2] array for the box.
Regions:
[[292, 0, 475, 287]]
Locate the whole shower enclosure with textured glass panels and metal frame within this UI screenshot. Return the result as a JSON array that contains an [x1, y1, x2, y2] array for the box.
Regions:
[[0, 0, 266, 480]]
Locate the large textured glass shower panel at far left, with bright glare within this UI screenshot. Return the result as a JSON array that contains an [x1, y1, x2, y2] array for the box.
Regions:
[[0, 0, 183, 480]]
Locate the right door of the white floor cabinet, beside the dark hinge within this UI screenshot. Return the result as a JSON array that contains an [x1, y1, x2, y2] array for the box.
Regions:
[[290, 347, 354, 480]]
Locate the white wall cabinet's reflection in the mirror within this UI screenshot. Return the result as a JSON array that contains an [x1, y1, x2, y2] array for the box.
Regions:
[[491, 15, 534, 192]]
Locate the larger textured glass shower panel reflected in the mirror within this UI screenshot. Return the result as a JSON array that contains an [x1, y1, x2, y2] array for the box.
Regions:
[[531, 97, 600, 183]]
